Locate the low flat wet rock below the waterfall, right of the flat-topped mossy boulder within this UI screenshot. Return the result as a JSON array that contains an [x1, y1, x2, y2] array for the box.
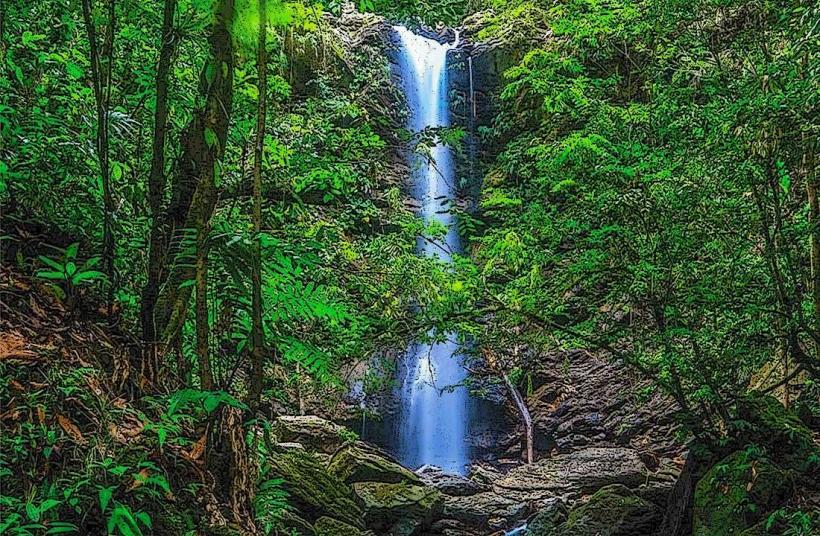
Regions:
[[442, 491, 529, 530]]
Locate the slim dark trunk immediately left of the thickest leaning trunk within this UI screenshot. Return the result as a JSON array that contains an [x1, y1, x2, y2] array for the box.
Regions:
[[140, 0, 177, 383]]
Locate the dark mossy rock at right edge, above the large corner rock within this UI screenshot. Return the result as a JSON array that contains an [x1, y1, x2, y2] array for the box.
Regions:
[[736, 393, 814, 469]]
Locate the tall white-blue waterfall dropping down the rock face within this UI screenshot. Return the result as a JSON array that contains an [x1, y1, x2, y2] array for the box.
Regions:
[[391, 26, 472, 474]]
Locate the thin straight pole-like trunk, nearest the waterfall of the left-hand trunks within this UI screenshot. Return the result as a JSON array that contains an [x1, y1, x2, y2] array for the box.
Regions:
[[248, 0, 268, 410]]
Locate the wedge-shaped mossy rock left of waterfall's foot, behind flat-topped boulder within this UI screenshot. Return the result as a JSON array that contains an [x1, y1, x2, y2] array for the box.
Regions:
[[328, 443, 420, 484]]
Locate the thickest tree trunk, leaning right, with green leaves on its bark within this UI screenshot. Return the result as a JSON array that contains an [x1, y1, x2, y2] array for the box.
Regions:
[[154, 0, 234, 345]]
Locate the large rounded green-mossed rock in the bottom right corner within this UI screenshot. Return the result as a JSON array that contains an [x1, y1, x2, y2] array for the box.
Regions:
[[693, 451, 791, 536]]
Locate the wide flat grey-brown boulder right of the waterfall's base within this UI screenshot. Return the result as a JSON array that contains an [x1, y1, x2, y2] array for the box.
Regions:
[[493, 447, 648, 503]]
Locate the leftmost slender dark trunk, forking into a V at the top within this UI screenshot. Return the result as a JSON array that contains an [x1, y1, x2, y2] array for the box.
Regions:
[[82, 0, 117, 321]]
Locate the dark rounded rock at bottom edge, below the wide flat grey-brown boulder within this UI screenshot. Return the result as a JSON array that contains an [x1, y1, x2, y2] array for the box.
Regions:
[[546, 484, 661, 536]]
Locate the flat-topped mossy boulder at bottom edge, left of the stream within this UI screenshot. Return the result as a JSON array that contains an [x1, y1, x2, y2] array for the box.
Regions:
[[353, 482, 444, 536]]
